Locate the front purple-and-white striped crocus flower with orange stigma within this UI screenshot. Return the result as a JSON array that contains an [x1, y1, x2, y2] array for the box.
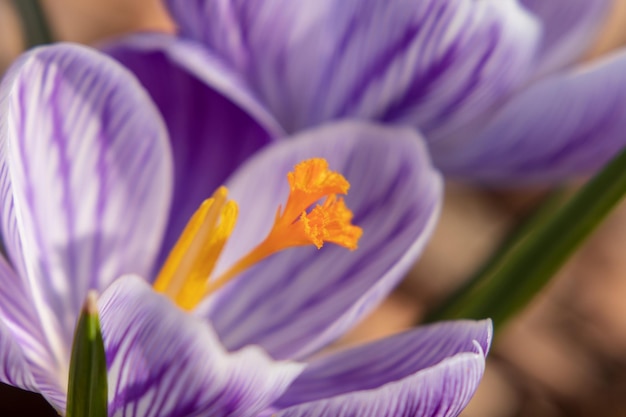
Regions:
[[0, 45, 491, 417]]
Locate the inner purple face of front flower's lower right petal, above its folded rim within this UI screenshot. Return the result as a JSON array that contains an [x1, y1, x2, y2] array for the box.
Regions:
[[276, 320, 492, 408]]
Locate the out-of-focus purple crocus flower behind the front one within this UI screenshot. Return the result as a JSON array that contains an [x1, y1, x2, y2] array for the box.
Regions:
[[109, 0, 626, 182]]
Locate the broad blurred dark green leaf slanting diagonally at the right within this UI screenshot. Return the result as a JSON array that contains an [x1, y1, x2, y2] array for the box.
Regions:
[[426, 146, 626, 330]]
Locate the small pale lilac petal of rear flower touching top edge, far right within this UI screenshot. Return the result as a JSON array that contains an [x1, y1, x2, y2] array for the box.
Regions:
[[521, 0, 614, 74]]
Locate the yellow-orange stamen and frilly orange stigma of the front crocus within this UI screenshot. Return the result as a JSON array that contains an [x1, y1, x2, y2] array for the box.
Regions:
[[154, 158, 363, 310]]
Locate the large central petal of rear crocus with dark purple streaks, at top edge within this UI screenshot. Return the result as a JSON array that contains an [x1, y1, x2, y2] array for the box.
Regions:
[[168, 0, 538, 137]]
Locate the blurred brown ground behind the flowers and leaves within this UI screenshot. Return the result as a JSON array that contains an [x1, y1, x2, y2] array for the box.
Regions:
[[0, 0, 626, 417]]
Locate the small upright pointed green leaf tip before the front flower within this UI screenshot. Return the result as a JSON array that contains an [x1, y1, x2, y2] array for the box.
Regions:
[[66, 291, 107, 417]]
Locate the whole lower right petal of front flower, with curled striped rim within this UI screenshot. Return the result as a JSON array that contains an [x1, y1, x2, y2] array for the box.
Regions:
[[275, 321, 491, 417]]
